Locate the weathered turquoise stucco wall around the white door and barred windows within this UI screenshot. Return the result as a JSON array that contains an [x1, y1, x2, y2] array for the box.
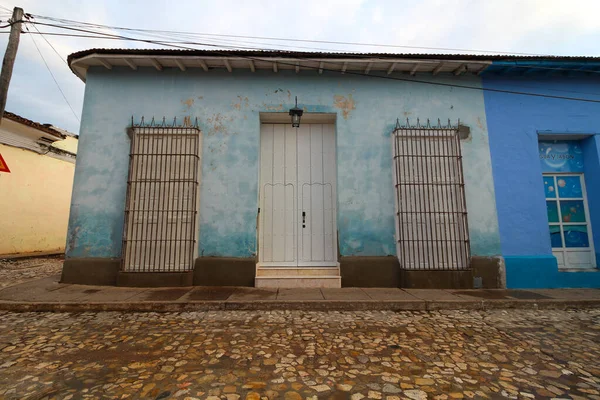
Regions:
[[67, 67, 500, 257]]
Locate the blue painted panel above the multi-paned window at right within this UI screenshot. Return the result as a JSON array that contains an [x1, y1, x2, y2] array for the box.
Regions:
[[539, 140, 583, 172]]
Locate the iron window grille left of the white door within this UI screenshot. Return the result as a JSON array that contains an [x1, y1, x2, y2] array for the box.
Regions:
[[122, 118, 201, 272]]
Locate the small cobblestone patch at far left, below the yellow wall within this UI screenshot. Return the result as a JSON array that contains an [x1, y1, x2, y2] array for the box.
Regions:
[[0, 257, 64, 289]]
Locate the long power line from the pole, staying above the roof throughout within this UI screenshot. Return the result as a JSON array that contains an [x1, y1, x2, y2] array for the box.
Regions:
[[32, 14, 549, 56]]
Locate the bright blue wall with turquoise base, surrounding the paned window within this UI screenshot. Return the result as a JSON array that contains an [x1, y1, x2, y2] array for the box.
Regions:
[[483, 75, 600, 288]]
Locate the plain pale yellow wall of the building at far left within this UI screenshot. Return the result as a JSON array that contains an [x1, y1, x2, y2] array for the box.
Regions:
[[0, 144, 75, 256]]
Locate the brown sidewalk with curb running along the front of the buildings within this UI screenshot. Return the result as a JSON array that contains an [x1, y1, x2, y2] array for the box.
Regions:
[[0, 275, 600, 312]]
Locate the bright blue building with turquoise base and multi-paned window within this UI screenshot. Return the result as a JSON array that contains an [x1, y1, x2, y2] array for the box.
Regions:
[[483, 58, 600, 288]]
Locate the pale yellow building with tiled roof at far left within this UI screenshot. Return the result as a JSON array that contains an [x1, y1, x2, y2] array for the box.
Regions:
[[0, 112, 77, 257]]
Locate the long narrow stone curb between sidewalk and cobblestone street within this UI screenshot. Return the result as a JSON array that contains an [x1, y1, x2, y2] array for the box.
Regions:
[[0, 299, 600, 312]]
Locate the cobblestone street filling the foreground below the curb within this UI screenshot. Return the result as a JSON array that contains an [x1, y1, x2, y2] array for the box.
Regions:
[[0, 309, 600, 400]]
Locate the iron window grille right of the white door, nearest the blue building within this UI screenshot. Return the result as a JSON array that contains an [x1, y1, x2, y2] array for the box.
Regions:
[[393, 120, 470, 270]]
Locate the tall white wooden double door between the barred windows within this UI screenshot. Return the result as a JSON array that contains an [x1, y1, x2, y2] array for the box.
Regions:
[[258, 124, 337, 267]]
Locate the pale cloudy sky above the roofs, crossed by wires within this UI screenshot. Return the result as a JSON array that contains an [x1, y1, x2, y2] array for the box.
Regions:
[[0, 0, 600, 133]]
